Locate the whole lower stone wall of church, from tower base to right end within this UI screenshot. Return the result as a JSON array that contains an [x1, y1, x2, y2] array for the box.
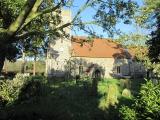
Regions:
[[46, 53, 145, 78]]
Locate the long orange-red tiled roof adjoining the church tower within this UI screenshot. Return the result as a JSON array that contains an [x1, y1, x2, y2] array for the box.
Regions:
[[72, 37, 131, 58]]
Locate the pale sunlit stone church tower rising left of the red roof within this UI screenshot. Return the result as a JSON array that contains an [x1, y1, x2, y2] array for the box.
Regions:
[[46, 10, 71, 76]]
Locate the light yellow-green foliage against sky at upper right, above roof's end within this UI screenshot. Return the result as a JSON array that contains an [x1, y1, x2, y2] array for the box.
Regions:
[[115, 0, 160, 51]]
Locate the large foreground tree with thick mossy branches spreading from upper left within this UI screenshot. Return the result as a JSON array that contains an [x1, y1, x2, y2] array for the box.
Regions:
[[0, 0, 136, 72]]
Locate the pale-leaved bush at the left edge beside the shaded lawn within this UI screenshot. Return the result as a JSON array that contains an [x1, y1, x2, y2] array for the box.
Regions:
[[0, 74, 46, 106]]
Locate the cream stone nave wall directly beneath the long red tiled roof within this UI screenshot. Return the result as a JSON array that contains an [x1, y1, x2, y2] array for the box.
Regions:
[[72, 57, 130, 78]]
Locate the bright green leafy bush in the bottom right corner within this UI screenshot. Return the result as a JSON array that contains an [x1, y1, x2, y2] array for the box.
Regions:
[[135, 81, 160, 119]]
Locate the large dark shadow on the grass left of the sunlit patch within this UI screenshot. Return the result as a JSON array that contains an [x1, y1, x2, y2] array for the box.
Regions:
[[4, 81, 107, 120]]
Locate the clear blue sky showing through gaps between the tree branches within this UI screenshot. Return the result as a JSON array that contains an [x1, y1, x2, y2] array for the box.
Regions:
[[72, 0, 143, 37]]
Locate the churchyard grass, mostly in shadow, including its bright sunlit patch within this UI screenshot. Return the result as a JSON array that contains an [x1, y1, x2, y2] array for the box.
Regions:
[[4, 79, 145, 120]]
